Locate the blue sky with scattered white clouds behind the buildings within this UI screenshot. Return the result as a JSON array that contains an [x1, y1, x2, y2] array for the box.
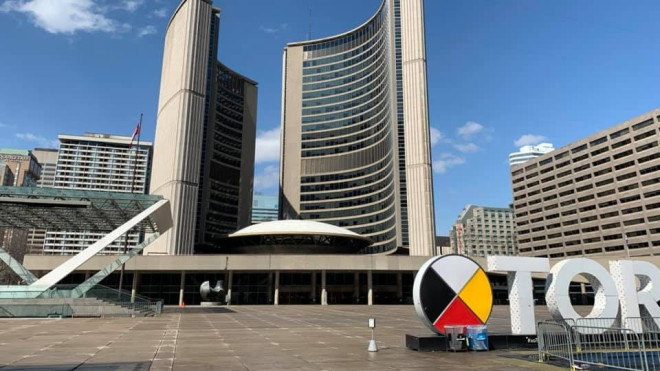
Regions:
[[0, 0, 660, 234]]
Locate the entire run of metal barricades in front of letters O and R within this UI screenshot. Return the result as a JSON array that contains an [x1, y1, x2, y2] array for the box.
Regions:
[[537, 317, 660, 371]]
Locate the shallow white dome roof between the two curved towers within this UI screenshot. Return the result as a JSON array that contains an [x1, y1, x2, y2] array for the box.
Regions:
[[229, 219, 368, 240]]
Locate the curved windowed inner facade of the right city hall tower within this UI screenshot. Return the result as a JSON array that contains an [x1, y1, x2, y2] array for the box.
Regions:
[[300, 1, 398, 252]]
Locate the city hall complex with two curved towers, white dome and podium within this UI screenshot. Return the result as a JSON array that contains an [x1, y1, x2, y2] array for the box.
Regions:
[[18, 0, 448, 304]]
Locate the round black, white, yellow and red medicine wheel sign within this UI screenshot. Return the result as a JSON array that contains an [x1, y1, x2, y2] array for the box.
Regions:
[[413, 255, 493, 334]]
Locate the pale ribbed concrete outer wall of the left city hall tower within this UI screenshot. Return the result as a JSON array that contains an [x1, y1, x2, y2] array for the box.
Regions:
[[145, 0, 211, 254]]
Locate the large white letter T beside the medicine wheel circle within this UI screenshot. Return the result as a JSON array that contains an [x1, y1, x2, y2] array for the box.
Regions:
[[488, 256, 548, 335]]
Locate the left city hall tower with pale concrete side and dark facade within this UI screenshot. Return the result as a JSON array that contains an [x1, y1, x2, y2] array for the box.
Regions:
[[145, 0, 257, 254]]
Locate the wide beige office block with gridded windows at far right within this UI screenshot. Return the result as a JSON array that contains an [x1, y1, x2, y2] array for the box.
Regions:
[[511, 109, 660, 258]]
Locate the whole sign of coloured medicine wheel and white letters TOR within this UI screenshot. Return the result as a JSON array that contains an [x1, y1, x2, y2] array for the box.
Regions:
[[413, 255, 660, 335]]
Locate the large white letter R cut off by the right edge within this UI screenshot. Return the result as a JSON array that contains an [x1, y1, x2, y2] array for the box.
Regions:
[[610, 260, 660, 333]]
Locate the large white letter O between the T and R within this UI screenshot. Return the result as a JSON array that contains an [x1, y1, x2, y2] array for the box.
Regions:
[[545, 258, 619, 334]]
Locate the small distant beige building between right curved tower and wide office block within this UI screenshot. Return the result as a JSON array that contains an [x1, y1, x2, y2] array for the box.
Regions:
[[449, 205, 518, 256]]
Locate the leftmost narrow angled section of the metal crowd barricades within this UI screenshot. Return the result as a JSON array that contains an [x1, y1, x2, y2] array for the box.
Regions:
[[536, 321, 573, 366]]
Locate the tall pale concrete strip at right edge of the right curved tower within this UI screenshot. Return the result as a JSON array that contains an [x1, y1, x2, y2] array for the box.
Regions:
[[400, 0, 435, 256]]
